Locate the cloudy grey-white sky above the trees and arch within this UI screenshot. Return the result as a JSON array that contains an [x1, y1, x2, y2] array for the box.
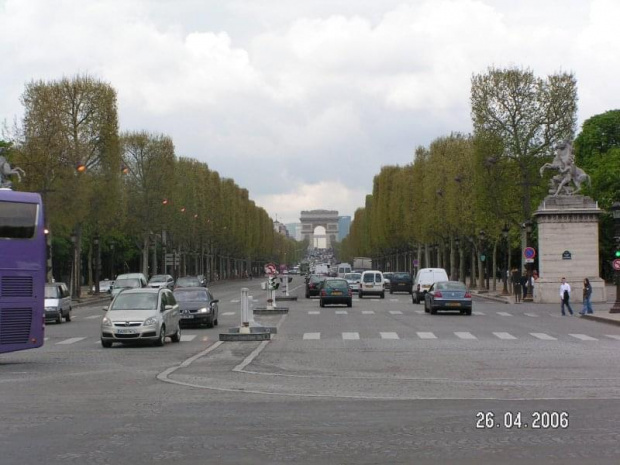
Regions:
[[0, 0, 620, 222]]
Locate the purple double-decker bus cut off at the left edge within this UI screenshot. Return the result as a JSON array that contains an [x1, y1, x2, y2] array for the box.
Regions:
[[0, 189, 46, 353]]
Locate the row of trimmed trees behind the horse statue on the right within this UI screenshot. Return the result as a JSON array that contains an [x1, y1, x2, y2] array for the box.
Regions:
[[341, 68, 620, 288]]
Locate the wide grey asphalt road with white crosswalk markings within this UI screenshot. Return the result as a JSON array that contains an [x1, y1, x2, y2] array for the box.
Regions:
[[0, 278, 620, 465]]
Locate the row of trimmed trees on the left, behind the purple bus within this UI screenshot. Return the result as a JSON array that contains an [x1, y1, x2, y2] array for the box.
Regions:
[[3, 75, 300, 289]]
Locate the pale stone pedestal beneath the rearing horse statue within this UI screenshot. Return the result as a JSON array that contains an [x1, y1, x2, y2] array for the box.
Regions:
[[534, 195, 606, 304]]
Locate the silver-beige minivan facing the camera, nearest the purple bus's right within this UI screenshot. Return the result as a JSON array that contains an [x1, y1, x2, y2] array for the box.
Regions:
[[101, 288, 181, 347]]
